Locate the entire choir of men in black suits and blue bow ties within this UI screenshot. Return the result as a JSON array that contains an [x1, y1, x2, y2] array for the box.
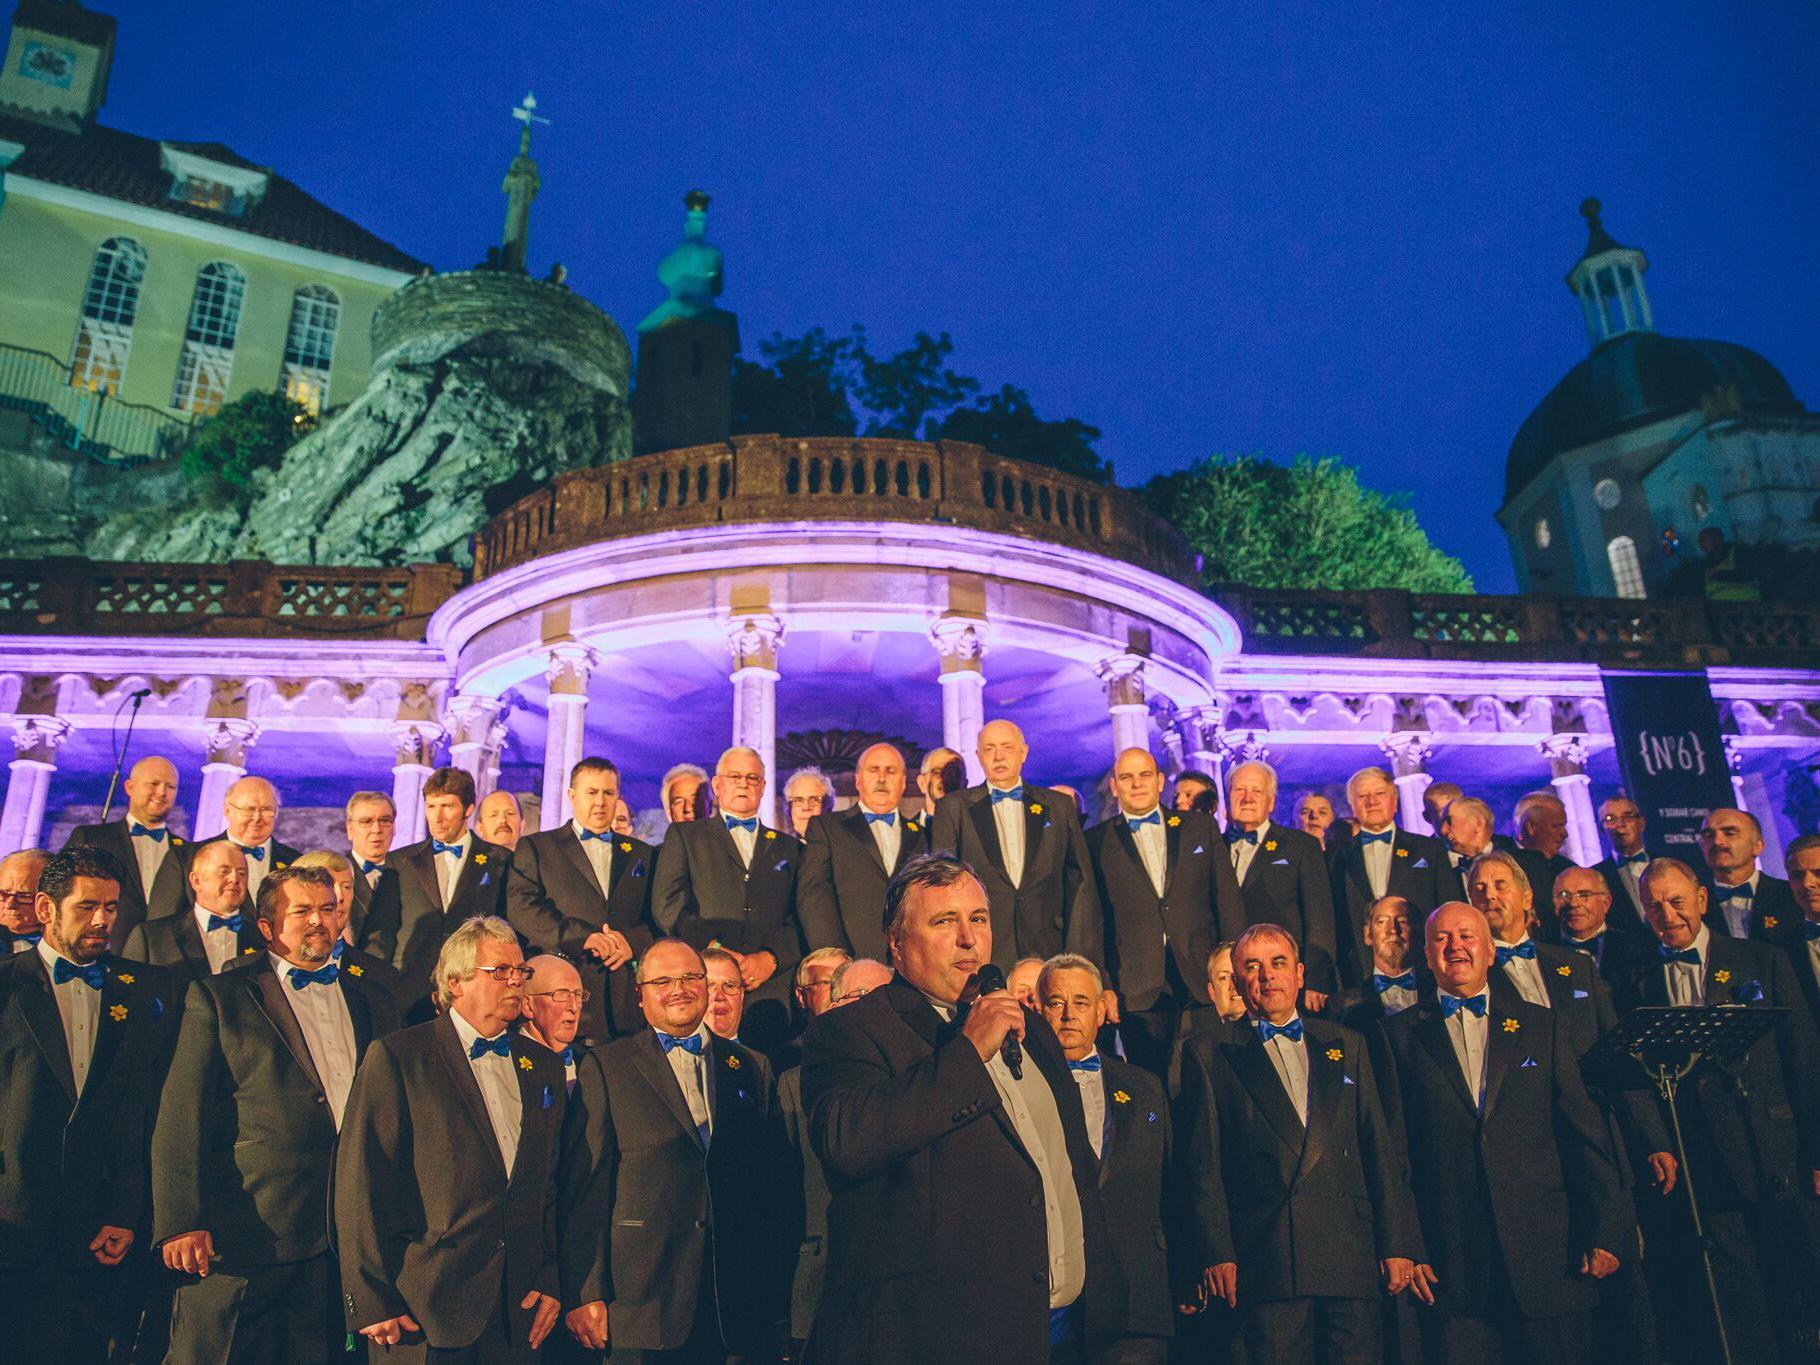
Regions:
[[0, 738, 1820, 1365]]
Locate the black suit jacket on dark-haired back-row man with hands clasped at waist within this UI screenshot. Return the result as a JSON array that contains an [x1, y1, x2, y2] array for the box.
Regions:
[[506, 824, 657, 1047]]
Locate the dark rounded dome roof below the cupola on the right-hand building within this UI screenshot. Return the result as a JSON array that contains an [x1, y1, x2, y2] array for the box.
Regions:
[[1503, 331, 1805, 502]]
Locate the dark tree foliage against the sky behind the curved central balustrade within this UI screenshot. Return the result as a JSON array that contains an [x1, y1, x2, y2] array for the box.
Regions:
[[733, 326, 1112, 482]]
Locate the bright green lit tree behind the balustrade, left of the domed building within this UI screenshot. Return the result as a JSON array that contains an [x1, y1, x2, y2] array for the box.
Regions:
[[1143, 455, 1472, 593]]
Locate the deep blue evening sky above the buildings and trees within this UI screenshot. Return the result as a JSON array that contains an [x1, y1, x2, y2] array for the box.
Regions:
[[117, 0, 1820, 592]]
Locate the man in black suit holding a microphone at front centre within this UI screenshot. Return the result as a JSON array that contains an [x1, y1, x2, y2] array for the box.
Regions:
[[803, 854, 1127, 1365]]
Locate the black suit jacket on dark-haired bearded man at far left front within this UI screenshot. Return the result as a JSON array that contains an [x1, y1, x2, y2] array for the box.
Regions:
[[0, 950, 177, 1274]]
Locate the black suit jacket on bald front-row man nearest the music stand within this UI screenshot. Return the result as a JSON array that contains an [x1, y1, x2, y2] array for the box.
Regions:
[[1380, 997, 1636, 1320]]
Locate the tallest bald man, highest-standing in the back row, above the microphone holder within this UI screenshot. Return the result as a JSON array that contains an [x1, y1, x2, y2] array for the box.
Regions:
[[928, 721, 1105, 970]]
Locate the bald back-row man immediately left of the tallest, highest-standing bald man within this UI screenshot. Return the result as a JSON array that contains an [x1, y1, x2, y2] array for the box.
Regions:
[[797, 744, 928, 957]]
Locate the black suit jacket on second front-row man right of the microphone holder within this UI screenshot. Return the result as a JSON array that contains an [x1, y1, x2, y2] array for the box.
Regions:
[[1181, 1017, 1423, 1305]]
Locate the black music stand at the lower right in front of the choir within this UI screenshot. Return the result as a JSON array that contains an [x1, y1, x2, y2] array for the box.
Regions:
[[1589, 1005, 1787, 1365]]
